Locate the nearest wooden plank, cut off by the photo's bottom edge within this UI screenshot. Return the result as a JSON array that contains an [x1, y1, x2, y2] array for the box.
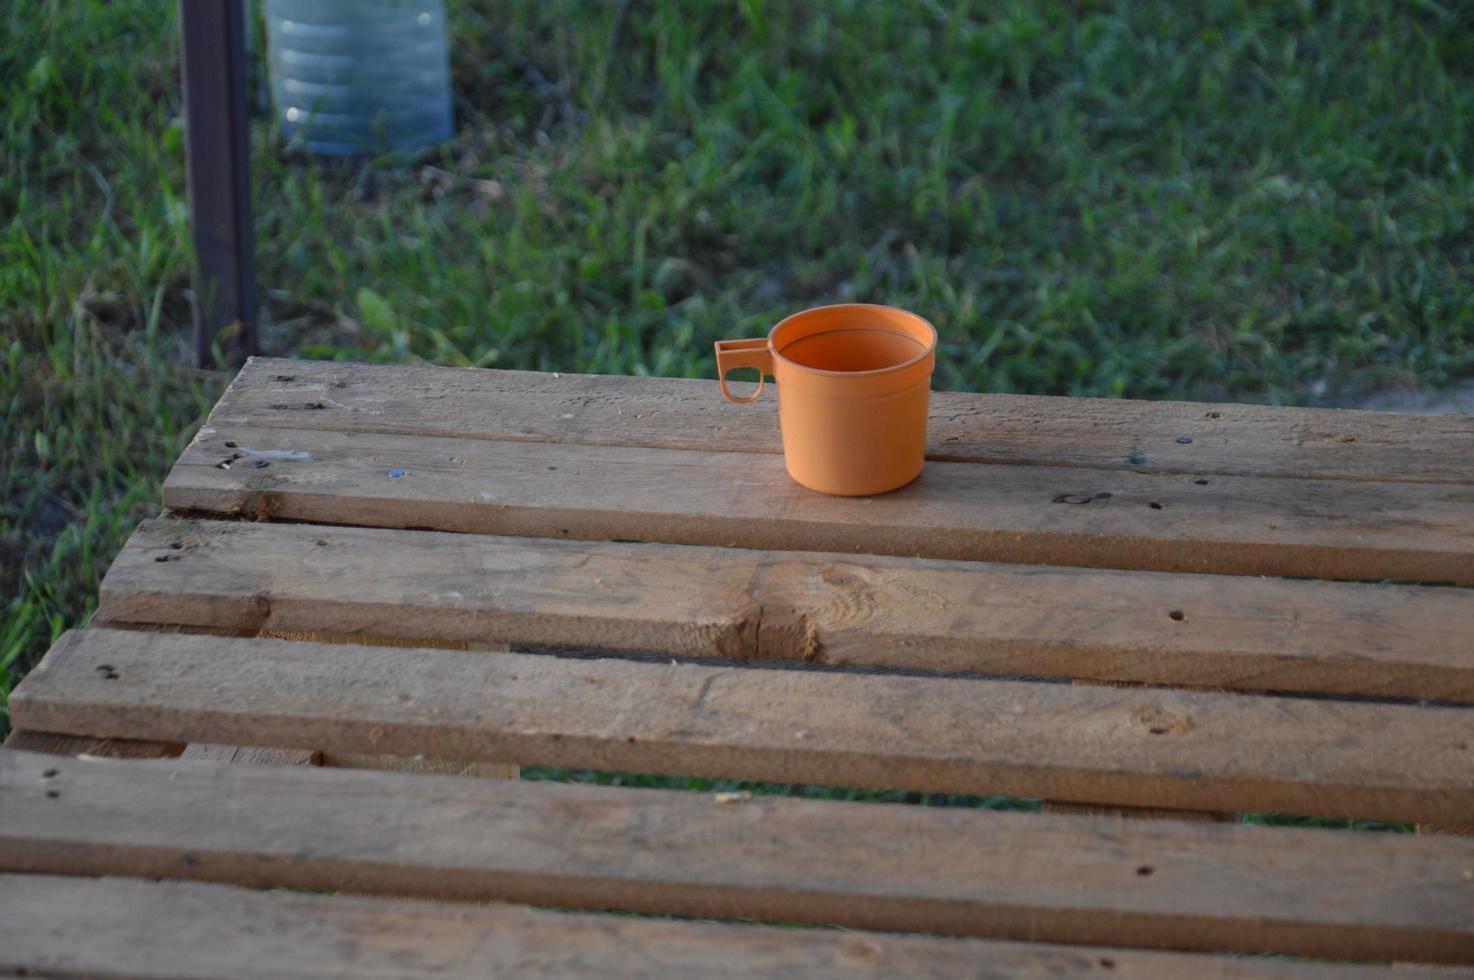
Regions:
[[0, 874, 1426, 980]]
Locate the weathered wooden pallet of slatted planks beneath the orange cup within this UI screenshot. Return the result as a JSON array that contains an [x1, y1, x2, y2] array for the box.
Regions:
[[0, 358, 1474, 977]]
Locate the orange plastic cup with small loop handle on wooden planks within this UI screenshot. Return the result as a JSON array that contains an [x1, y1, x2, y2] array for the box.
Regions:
[[716, 304, 936, 497]]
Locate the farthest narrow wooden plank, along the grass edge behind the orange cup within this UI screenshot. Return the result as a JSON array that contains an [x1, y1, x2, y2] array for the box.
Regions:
[[208, 358, 1474, 483]]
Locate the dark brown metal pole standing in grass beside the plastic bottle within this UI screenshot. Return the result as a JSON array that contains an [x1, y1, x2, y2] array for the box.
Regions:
[[180, 0, 256, 367]]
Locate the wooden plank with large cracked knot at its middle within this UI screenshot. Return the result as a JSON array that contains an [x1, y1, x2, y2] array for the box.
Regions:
[[96, 520, 1474, 701]]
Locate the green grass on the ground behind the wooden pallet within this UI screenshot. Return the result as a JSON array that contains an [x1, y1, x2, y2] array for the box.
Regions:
[[0, 0, 1474, 831]]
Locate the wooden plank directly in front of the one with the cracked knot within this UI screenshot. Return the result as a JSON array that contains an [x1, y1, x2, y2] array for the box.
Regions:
[[10, 629, 1474, 824]]
